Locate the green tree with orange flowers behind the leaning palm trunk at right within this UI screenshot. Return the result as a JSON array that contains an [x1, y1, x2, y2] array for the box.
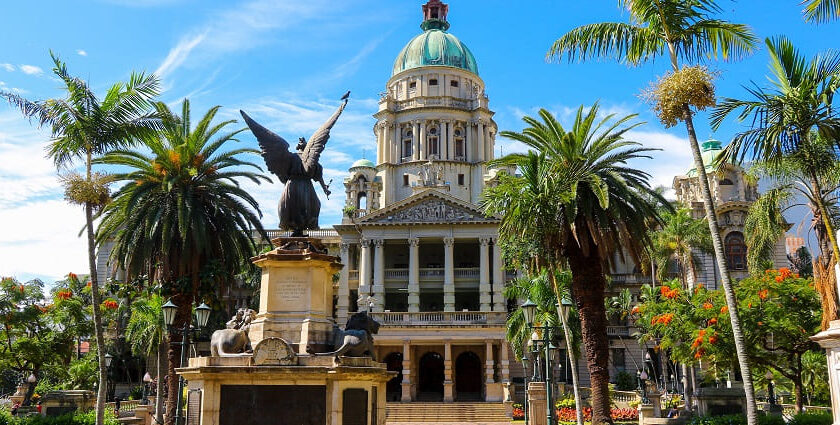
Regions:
[[634, 268, 822, 410]]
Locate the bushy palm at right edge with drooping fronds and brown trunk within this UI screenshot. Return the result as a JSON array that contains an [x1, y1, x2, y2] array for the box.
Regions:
[[712, 37, 840, 320]]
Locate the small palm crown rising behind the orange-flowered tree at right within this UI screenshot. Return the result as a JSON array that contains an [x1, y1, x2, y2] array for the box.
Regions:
[[651, 208, 712, 288]]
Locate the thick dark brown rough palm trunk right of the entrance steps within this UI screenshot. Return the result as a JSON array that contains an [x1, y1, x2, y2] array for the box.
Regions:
[[567, 247, 613, 424]]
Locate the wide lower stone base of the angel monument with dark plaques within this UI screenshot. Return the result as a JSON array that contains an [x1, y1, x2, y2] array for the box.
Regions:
[[182, 355, 395, 425]]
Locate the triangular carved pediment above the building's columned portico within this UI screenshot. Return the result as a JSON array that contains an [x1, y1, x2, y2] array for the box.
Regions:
[[359, 191, 498, 224]]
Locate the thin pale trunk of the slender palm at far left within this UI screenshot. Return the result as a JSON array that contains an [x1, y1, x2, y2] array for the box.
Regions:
[[85, 149, 108, 425]]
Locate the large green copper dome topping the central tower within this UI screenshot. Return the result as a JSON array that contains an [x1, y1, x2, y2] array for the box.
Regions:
[[391, 19, 478, 75]]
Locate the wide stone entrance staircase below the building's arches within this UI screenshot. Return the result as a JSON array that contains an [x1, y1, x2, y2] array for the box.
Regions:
[[385, 402, 510, 425]]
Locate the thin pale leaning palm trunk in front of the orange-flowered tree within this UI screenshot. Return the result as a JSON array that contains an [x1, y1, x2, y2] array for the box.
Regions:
[[683, 105, 758, 425]]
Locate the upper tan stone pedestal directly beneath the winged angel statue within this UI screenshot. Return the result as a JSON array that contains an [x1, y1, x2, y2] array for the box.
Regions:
[[248, 237, 343, 354]]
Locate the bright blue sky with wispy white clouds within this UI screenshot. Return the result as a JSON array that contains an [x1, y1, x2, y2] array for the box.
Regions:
[[0, 0, 840, 282]]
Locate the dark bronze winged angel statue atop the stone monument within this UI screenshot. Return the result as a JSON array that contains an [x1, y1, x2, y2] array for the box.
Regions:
[[239, 91, 350, 237]]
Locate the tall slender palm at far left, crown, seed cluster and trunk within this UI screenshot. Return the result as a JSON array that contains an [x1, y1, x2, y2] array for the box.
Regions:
[[0, 52, 159, 425]]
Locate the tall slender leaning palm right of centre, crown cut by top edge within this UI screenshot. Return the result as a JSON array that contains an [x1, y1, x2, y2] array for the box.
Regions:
[[548, 0, 758, 425]]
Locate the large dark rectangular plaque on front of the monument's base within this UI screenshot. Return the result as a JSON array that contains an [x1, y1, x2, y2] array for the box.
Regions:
[[219, 385, 327, 425]]
